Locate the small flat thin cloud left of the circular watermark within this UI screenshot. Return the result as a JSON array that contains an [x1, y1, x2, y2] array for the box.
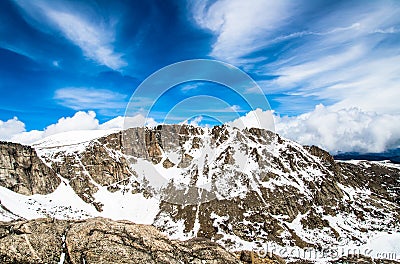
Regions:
[[54, 87, 126, 110]]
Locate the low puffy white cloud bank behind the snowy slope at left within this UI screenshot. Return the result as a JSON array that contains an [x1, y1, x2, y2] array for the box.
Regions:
[[4, 111, 157, 144]]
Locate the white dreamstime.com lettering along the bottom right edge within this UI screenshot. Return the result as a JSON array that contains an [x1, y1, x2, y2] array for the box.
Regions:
[[253, 243, 400, 261]]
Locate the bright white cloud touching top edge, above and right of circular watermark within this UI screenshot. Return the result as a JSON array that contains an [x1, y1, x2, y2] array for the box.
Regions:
[[192, 0, 294, 63]]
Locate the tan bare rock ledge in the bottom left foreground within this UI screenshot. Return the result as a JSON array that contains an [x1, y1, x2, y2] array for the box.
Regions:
[[0, 218, 242, 264]]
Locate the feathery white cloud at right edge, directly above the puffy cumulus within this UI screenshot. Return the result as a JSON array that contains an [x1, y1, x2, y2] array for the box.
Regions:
[[266, 49, 400, 113]]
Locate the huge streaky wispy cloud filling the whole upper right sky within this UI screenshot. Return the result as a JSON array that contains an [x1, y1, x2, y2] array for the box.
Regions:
[[192, 0, 400, 113]]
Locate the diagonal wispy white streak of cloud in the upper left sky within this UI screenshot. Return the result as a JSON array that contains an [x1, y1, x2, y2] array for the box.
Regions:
[[15, 0, 127, 70]]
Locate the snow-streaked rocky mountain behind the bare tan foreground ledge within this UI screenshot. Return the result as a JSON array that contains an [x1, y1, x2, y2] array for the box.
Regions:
[[0, 125, 400, 260]]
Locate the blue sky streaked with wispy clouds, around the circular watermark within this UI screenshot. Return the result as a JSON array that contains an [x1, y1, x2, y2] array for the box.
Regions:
[[0, 0, 400, 153]]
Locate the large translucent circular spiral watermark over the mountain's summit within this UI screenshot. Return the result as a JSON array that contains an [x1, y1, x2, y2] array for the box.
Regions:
[[122, 59, 275, 205]]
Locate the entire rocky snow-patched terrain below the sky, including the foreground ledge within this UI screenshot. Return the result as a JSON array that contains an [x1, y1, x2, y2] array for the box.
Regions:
[[0, 125, 400, 263]]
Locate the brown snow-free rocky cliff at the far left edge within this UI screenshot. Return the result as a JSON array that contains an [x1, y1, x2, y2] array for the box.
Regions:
[[0, 142, 61, 195]]
